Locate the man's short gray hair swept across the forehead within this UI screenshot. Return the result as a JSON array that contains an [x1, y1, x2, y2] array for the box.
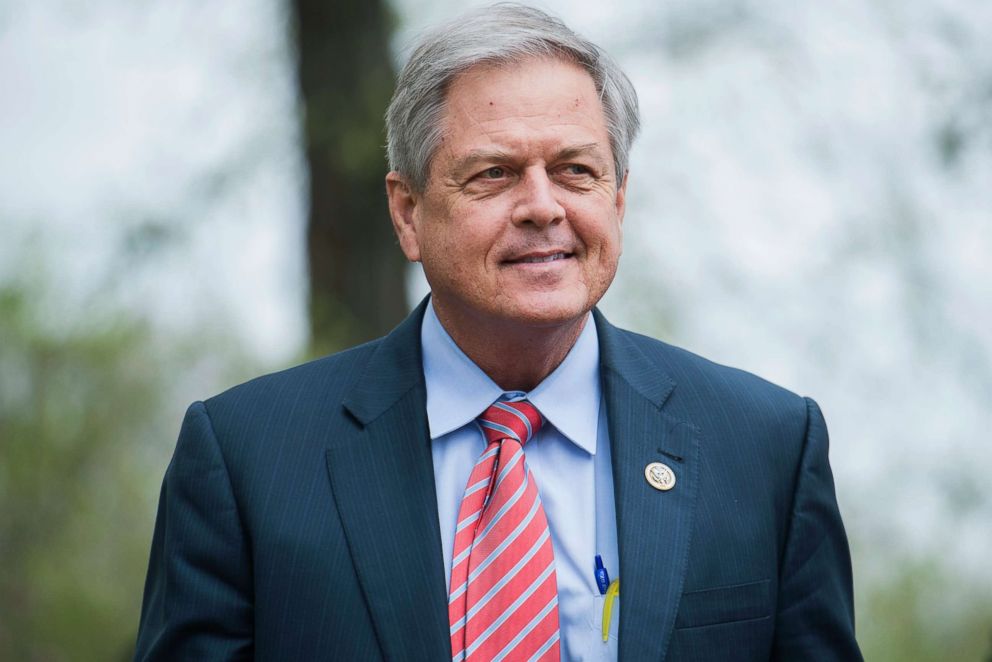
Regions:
[[386, 2, 640, 191]]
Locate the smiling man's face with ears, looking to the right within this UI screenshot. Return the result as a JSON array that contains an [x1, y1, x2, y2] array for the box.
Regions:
[[387, 59, 626, 333]]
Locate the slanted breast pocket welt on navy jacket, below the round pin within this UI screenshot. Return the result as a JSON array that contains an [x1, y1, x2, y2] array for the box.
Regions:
[[675, 579, 771, 629]]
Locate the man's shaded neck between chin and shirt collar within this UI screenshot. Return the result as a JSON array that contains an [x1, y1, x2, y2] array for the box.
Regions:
[[435, 307, 589, 391]]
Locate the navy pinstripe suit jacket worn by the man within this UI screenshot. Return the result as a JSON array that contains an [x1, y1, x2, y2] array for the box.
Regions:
[[136, 305, 861, 662]]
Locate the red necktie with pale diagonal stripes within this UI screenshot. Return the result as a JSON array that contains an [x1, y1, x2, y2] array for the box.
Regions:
[[448, 400, 560, 662]]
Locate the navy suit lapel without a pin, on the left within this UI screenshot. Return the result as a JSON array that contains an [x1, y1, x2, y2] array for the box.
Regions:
[[327, 304, 451, 660]]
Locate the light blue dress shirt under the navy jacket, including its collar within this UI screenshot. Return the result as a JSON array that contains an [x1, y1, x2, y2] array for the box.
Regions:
[[420, 303, 620, 662]]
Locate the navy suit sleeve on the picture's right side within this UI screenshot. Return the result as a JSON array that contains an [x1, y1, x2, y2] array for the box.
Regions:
[[772, 398, 862, 662]]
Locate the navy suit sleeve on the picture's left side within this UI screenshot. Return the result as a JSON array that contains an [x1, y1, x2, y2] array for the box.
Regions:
[[134, 402, 253, 660]]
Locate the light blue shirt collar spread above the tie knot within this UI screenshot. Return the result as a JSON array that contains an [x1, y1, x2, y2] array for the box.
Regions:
[[420, 301, 602, 455]]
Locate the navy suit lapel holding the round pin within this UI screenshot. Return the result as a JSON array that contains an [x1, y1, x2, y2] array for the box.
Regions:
[[596, 311, 700, 660]]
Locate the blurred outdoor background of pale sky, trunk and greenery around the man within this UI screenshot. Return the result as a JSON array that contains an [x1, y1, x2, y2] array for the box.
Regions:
[[0, 0, 992, 661]]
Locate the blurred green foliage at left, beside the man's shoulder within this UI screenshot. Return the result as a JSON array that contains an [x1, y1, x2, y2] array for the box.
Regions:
[[0, 281, 257, 660]]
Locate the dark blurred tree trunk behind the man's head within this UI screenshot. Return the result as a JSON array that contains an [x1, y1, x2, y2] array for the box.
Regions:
[[293, 0, 407, 351]]
